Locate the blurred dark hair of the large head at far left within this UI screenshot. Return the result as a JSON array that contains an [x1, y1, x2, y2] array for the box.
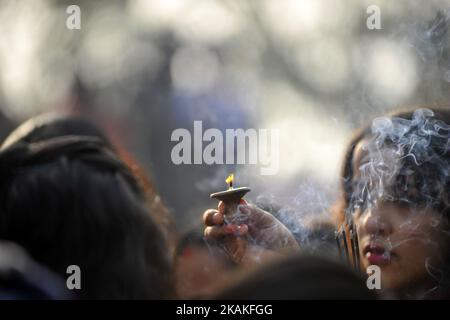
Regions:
[[0, 117, 173, 299]]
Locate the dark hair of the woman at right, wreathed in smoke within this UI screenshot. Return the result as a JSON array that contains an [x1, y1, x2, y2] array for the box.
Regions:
[[341, 108, 450, 218]]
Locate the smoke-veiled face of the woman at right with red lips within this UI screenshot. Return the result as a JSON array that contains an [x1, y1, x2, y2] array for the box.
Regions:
[[354, 141, 448, 292]]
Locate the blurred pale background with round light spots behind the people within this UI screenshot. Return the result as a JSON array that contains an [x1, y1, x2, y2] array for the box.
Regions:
[[0, 0, 450, 231]]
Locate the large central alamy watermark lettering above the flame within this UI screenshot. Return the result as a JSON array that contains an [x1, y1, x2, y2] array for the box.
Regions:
[[170, 121, 279, 175]]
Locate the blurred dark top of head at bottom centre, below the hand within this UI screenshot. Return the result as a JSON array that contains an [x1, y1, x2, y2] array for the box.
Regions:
[[217, 256, 376, 300]]
